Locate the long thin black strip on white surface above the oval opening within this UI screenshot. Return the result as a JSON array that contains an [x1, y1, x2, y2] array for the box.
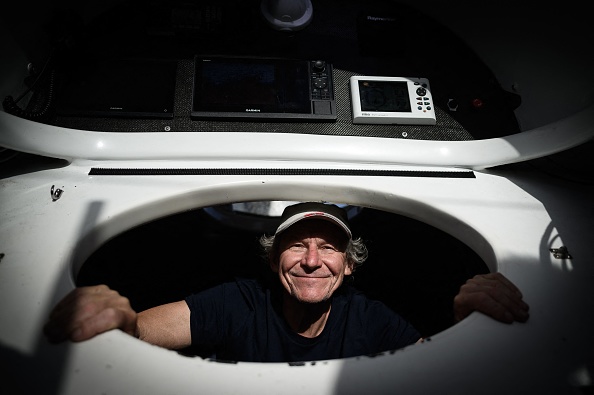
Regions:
[[89, 167, 476, 178]]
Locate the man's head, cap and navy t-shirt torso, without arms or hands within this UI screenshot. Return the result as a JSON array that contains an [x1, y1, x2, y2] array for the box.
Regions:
[[186, 203, 421, 362]]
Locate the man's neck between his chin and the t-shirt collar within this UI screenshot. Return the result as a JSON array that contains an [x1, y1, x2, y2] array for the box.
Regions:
[[283, 294, 332, 338]]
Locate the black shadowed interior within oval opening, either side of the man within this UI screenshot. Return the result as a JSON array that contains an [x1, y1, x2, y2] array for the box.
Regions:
[[77, 204, 488, 337]]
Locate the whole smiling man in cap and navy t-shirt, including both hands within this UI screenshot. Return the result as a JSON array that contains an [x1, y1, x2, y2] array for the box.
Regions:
[[44, 203, 528, 362]]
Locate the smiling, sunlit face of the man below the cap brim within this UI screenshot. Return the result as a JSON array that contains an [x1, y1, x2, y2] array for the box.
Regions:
[[272, 219, 352, 303]]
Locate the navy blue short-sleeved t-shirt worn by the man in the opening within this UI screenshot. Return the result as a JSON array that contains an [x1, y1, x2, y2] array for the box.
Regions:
[[186, 279, 421, 362]]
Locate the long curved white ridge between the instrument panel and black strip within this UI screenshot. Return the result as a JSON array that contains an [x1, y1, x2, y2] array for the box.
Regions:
[[0, 105, 594, 169]]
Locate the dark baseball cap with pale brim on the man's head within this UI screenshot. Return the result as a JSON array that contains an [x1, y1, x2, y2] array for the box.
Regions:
[[275, 202, 353, 239]]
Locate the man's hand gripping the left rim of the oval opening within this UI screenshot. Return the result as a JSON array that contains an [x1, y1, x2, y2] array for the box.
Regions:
[[43, 285, 137, 343]]
